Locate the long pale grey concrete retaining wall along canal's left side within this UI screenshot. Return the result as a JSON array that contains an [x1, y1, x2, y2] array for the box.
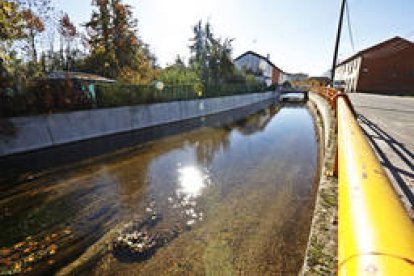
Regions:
[[0, 92, 274, 157]]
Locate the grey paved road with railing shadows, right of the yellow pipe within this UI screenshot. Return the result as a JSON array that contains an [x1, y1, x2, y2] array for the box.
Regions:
[[349, 93, 414, 213]]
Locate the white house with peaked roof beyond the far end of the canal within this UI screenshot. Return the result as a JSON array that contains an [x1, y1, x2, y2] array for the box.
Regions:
[[234, 51, 283, 86]]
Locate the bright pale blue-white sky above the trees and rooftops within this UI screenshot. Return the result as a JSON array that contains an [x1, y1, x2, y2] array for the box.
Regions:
[[55, 0, 414, 76]]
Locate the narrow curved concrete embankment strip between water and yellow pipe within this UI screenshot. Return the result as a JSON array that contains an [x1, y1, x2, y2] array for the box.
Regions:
[[301, 92, 338, 275]]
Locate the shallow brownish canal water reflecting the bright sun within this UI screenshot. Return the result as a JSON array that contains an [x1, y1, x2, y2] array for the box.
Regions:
[[0, 103, 319, 275]]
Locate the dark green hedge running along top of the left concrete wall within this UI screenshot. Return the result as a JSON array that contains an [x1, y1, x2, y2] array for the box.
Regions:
[[0, 83, 265, 117]]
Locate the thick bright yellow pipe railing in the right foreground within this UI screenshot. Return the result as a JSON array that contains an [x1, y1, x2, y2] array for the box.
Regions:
[[337, 97, 414, 276]]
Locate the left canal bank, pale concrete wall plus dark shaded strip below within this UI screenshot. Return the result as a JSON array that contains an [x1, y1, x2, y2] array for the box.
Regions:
[[0, 92, 275, 181]]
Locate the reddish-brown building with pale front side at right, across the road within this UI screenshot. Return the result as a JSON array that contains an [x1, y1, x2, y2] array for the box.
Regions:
[[335, 37, 414, 94]]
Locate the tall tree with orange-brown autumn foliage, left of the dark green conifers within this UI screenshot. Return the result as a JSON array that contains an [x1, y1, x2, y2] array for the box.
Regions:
[[85, 0, 158, 83]]
